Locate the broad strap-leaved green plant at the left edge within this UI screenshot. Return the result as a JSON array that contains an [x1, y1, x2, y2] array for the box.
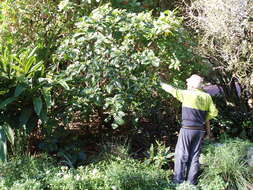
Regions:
[[0, 48, 68, 156]]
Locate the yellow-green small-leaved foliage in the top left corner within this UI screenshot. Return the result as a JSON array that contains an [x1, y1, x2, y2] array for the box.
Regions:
[[0, 0, 109, 69]]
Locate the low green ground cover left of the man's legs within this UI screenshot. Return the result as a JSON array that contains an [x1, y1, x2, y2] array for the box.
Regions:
[[0, 151, 173, 190]]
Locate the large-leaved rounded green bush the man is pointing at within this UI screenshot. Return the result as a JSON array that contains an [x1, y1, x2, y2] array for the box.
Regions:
[[55, 4, 204, 128]]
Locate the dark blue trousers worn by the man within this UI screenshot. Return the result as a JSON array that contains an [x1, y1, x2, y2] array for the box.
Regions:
[[173, 128, 205, 185]]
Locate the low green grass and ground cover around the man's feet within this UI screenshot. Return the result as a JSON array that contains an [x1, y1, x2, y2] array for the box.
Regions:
[[0, 139, 253, 190]]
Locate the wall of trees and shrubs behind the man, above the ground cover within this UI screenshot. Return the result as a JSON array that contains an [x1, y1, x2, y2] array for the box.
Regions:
[[0, 0, 253, 188]]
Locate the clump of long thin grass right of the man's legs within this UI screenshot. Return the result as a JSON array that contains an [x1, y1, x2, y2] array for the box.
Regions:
[[200, 139, 253, 190]]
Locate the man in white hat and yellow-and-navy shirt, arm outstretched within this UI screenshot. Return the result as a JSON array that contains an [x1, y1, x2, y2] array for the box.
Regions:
[[161, 74, 218, 185]]
